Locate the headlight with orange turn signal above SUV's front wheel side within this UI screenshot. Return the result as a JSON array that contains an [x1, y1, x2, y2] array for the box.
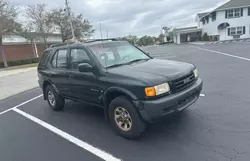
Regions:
[[145, 83, 170, 97]]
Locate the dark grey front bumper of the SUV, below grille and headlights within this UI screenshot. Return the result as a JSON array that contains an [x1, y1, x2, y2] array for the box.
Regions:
[[135, 78, 203, 122]]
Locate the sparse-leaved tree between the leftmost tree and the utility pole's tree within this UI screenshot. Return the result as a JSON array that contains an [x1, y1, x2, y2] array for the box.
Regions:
[[26, 4, 54, 46]]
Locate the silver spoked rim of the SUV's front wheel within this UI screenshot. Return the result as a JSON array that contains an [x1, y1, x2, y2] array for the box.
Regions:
[[114, 107, 132, 131]]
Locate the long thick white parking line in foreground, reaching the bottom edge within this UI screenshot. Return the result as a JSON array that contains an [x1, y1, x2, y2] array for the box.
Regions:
[[12, 108, 121, 161]]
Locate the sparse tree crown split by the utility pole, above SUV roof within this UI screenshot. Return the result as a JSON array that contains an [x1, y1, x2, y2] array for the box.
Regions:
[[50, 8, 95, 42]]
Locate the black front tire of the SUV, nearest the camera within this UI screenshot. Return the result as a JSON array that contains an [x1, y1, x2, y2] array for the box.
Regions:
[[108, 96, 146, 139]]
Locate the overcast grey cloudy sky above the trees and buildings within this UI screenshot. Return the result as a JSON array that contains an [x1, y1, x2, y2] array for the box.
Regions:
[[8, 0, 229, 38]]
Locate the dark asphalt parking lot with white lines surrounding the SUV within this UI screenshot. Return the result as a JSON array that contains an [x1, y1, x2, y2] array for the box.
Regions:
[[0, 43, 250, 161]]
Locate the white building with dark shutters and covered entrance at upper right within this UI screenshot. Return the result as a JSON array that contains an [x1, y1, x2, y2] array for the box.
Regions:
[[175, 0, 250, 43]]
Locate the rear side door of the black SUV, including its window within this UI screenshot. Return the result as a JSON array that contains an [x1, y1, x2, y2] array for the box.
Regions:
[[49, 48, 70, 96]]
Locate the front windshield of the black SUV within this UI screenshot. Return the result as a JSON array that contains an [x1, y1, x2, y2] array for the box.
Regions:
[[89, 42, 150, 67]]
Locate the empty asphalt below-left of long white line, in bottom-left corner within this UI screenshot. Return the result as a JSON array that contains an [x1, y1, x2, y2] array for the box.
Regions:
[[0, 111, 101, 161]]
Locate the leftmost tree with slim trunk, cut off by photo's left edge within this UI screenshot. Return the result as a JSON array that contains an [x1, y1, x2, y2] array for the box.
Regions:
[[0, 0, 19, 67]]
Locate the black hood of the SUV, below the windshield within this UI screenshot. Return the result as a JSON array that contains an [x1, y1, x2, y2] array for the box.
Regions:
[[108, 59, 195, 85]]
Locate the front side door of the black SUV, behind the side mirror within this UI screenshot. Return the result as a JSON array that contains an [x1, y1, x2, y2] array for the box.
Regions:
[[69, 48, 101, 104]]
